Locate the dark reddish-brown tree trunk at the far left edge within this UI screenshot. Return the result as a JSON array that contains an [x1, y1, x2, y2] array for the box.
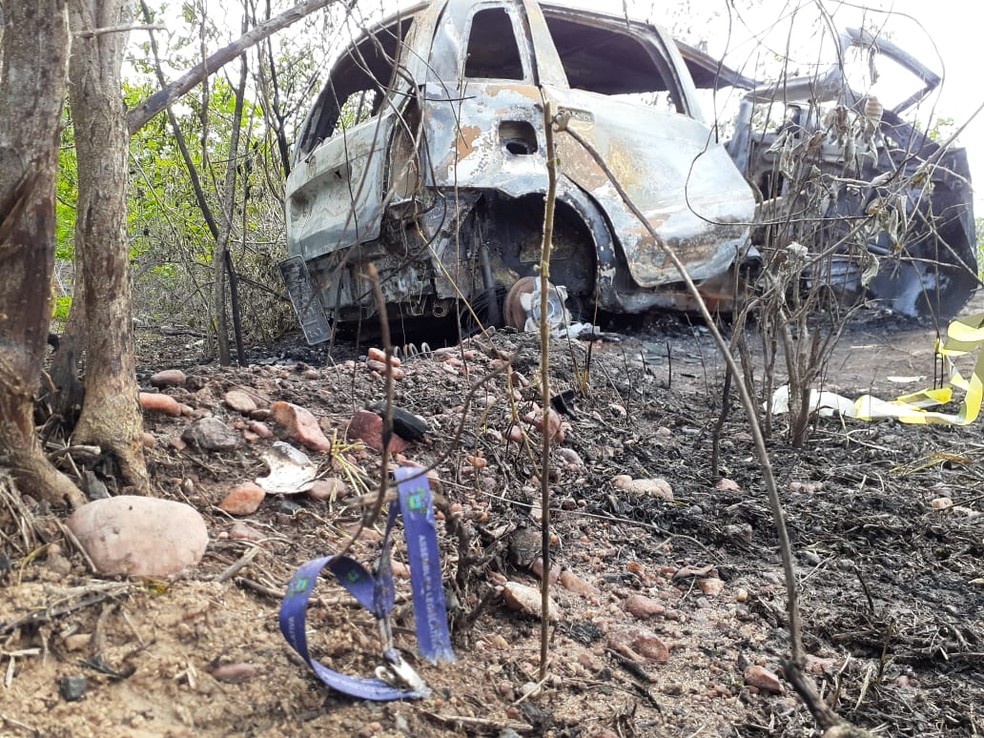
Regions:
[[0, 0, 85, 505]]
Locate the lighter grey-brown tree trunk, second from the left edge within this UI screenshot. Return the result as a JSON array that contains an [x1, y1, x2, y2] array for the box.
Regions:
[[69, 0, 149, 492]]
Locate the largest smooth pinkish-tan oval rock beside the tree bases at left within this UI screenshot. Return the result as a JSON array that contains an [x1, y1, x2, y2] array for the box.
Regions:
[[68, 495, 208, 577]]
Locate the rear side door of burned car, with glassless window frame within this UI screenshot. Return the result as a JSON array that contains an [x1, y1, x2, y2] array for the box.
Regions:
[[528, 2, 754, 287]]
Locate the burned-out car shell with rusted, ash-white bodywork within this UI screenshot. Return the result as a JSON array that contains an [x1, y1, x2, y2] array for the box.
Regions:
[[281, 0, 976, 343]]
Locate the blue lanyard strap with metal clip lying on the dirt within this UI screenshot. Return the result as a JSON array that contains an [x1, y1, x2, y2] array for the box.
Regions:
[[280, 467, 454, 701]]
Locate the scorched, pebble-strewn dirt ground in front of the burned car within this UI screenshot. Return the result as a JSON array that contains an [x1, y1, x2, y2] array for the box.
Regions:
[[0, 308, 984, 737]]
